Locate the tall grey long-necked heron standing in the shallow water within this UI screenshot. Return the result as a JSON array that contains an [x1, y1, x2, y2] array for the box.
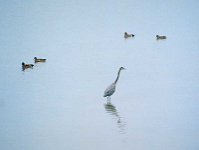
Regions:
[[104, 67, 125, 99]]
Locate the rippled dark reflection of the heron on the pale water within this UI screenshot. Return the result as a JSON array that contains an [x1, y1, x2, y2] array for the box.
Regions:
[[104, 102, 126, 134]]
